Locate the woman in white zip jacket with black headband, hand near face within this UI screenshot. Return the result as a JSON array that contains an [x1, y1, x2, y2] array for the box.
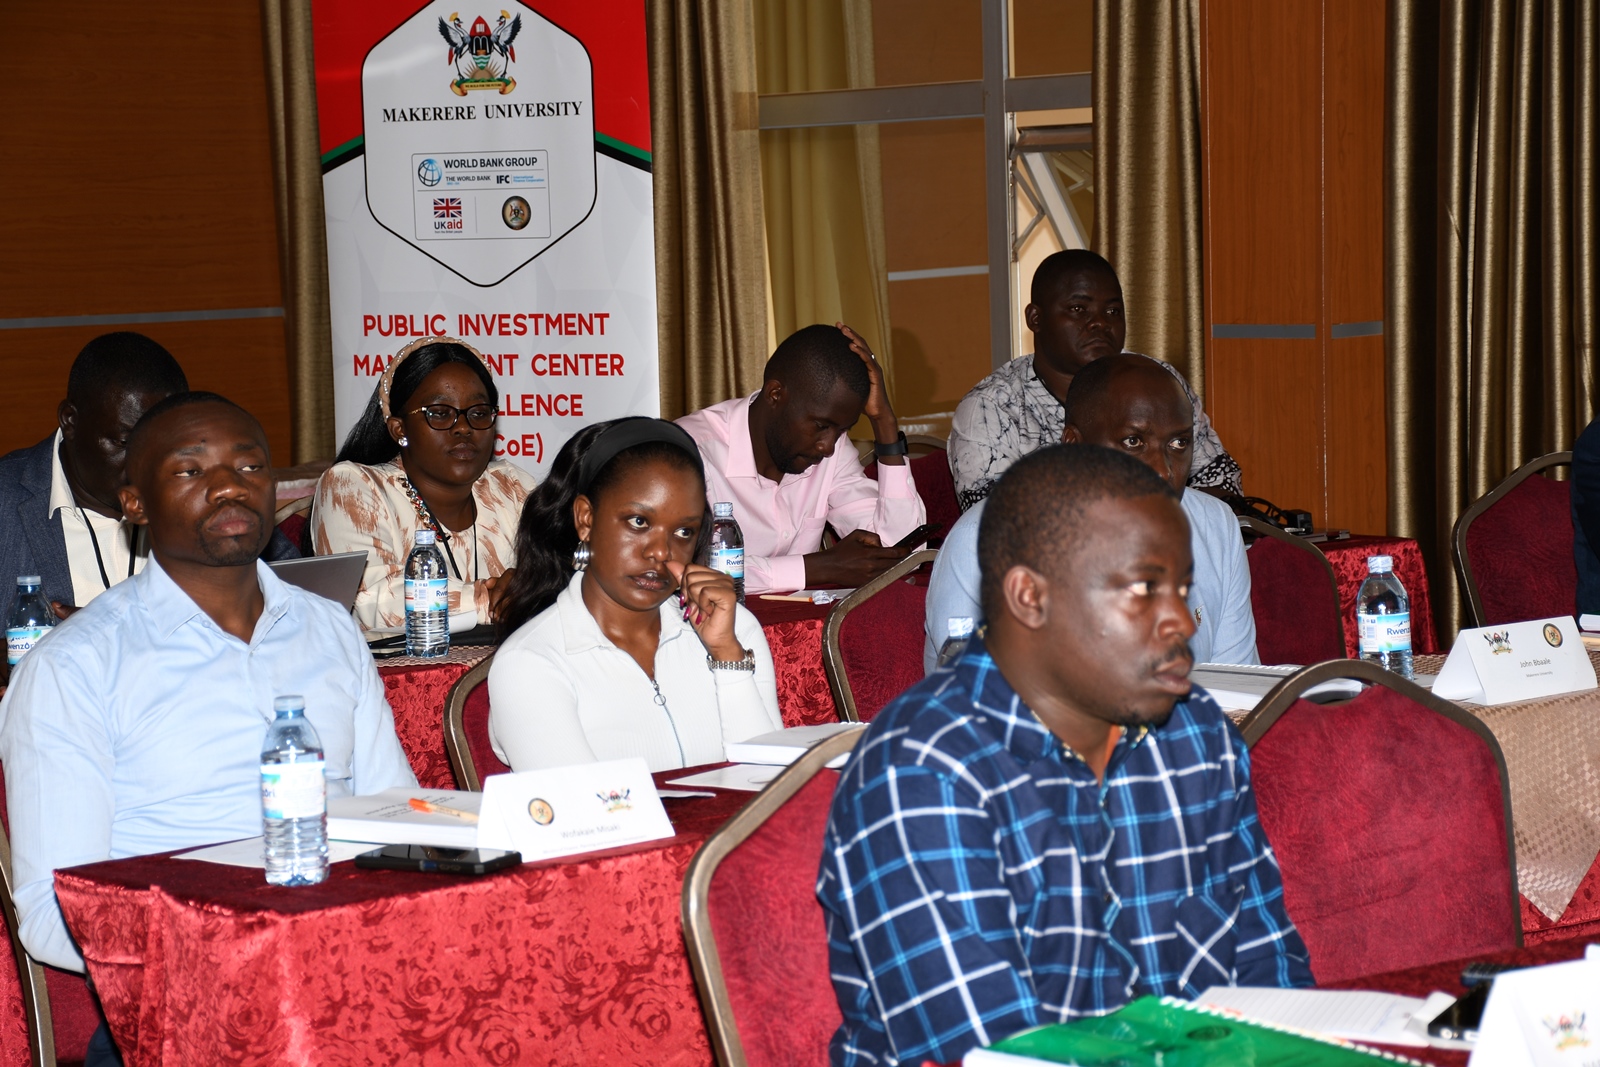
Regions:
[[490, 418, 782, 771]]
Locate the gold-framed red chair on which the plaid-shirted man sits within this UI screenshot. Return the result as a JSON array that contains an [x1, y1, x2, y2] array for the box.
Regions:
[[683, 729, 862, 1067]]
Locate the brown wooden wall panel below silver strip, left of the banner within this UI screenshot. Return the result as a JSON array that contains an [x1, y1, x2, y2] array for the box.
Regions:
[[0, 318, 290, 467]]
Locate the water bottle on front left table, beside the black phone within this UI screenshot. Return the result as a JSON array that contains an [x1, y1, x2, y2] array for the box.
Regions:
[[261, 696, 328, 886]]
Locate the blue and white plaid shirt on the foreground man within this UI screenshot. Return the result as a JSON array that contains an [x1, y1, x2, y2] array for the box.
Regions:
[[818, 640, 1312, 1065]]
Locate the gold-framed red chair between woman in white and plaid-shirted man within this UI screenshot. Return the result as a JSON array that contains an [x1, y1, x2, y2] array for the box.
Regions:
[[822, 549, 939, 723]]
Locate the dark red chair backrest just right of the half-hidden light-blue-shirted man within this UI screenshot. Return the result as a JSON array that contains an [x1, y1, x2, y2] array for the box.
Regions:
[[1238, 515, 1346, 664]]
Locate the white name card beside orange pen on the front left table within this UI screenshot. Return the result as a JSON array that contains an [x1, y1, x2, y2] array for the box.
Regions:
[[478, 757, 674, 861]]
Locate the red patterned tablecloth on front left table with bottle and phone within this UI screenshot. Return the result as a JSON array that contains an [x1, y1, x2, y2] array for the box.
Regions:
[[56, 771, 750, 1067]]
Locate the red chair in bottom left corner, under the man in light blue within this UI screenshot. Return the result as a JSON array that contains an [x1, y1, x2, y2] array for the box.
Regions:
[[0, 771, 101, 1067]]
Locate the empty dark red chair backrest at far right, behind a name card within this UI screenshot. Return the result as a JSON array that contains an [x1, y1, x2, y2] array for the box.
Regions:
[[1450, 453, 1578, 625]]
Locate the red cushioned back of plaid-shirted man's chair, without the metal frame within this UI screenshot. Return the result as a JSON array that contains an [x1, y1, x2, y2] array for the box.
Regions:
[[707, 769, 843, 1067]]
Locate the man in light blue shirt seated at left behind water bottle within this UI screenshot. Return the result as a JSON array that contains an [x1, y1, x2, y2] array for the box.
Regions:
[[0, 392, 416, 971]]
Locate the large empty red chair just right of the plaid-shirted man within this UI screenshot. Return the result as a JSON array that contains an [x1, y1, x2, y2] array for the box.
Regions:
[[1240, 659, 1522, 984]]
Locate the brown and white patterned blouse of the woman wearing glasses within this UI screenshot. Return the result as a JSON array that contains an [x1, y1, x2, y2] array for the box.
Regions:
[[310, 458, 538, 630]]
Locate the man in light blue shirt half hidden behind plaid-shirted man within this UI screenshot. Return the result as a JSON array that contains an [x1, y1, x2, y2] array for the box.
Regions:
[[922, 352, 1261, 673]]
